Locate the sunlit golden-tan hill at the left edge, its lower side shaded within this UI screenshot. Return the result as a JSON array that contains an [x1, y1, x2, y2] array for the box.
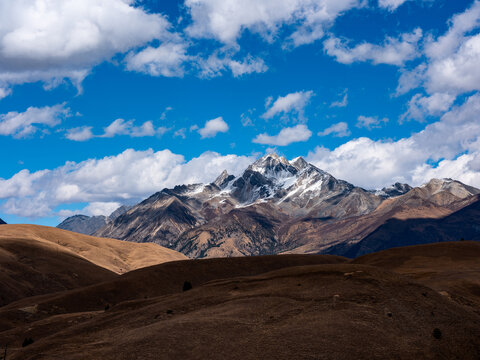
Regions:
[[0, 225, 185, 306]]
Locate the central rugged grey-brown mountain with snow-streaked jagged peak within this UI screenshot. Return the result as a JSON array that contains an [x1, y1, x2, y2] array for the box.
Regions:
[[96, 154, 412, 257]]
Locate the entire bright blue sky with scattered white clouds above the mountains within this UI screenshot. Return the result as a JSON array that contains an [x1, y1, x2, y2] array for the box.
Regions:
[[0, 0, 480, 225]]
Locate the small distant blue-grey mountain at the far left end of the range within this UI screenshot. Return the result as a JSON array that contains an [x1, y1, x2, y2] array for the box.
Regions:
[[57, 205, 131, 235]]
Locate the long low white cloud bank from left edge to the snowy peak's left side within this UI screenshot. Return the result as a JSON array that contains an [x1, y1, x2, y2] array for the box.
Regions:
[[0, 149, 254, 217]]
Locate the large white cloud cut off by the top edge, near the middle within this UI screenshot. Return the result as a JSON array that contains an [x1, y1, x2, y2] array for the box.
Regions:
[[185, 0, 362, 46]]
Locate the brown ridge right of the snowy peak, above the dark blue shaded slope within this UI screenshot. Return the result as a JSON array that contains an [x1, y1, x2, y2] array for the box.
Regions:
[[279, 179, 479, 258]]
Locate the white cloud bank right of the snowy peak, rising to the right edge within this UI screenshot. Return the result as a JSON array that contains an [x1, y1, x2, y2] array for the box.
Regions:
[[307, 94, 480, 188]]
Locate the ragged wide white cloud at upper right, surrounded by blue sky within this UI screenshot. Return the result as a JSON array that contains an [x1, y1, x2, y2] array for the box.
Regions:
[[323, 28, 422, 66]]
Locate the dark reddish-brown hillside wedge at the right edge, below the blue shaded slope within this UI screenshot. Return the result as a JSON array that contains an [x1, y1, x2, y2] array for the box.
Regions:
[[353, 241, 480, 313]]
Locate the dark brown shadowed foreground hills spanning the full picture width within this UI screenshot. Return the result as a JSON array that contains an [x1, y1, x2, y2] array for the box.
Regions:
[[0, 225, 480, 360]]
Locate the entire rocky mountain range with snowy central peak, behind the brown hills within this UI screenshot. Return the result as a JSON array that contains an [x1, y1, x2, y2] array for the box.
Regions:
[[59, 154, 480, 258]]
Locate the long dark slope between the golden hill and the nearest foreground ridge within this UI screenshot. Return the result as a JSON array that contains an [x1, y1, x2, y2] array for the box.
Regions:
[[0, 255, 347, 331]]
